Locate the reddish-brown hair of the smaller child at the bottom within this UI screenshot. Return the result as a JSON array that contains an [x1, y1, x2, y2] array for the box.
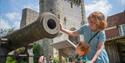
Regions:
[[77, 41, 90, 53]]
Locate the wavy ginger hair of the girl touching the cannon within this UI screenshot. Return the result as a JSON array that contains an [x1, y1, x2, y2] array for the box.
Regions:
[[88, 11, 107, 30]]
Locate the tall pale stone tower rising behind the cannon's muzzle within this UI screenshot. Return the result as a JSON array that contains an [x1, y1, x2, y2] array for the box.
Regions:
[[39, 0, 85, 61]]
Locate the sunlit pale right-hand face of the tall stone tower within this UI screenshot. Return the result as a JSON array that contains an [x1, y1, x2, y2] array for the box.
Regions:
[[47, 0, 85, 56]]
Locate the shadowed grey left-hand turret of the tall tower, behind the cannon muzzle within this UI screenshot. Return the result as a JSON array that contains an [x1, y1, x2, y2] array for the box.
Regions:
[[39, 0, 62, 61]]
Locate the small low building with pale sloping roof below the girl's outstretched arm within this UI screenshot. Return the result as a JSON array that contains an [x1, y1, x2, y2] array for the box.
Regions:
[[52, 40, 76, 57]]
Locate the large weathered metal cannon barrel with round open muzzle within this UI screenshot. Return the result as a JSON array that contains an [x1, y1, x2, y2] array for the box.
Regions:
[[6, 12, 60, 50]]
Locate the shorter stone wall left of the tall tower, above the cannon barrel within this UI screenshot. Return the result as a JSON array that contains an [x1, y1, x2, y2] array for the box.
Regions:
[[20, 8, 39, 28]]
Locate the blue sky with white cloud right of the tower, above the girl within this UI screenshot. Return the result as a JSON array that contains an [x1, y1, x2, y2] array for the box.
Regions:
[[85, 0, 125, 16]]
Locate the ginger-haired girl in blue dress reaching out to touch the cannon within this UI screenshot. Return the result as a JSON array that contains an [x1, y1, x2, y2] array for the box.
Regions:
[[60, 11, 109, 63]]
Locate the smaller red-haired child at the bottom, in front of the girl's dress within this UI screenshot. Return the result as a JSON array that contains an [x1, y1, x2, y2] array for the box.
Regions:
[[75, 41, 90, 63]]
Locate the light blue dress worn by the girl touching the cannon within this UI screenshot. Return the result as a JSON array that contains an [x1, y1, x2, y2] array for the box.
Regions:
[[76, 25, 109, 63]]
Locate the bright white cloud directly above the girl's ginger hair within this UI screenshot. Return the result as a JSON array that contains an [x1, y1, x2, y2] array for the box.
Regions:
[[85, 0, 112, 16]]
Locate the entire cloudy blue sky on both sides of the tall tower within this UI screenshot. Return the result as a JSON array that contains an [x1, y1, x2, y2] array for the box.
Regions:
[[0, 0, 125, 29]]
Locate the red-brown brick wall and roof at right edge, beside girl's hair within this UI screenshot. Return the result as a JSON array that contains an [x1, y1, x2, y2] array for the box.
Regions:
[[106, 11, 125, 39]]
